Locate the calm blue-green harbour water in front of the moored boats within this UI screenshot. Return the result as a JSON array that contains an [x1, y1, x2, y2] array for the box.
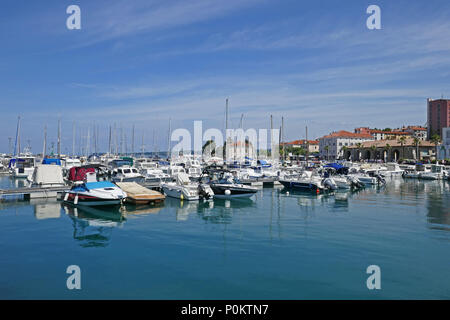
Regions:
[[0, 177, 450, 299]]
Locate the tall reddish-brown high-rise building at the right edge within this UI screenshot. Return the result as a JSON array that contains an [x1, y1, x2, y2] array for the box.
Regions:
[[427, 99, 450, 139]]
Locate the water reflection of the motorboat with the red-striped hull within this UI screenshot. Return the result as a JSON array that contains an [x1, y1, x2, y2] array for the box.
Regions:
[[61, 204, 125, 247]]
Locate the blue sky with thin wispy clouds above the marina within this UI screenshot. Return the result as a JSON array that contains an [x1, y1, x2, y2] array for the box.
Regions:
[[0, 0, 450, 152]]
